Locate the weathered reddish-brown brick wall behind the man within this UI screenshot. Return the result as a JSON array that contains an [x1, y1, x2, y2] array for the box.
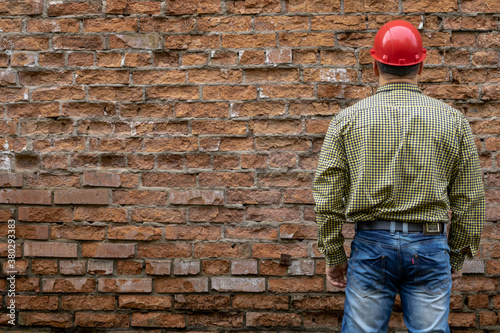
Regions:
[[0, 0, 500, 332]]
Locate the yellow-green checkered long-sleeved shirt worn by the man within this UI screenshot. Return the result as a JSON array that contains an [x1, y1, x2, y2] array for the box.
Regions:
[[313, 83, 485, 270]]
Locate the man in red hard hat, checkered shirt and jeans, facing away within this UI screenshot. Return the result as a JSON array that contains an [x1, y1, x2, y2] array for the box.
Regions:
[[313, 20, 484, 333]]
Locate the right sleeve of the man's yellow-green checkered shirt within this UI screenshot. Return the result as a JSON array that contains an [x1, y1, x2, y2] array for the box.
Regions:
[[448, 117, 485, 270]]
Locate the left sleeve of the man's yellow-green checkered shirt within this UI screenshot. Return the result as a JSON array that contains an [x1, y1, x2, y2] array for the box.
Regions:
[[313, 114, 348, 266]]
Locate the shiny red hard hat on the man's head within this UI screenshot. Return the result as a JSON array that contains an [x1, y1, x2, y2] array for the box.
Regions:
[[370, 20, 427, 66]]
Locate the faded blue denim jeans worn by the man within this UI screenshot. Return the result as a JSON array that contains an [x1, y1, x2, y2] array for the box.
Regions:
[[342, 230, 452, 333]]
